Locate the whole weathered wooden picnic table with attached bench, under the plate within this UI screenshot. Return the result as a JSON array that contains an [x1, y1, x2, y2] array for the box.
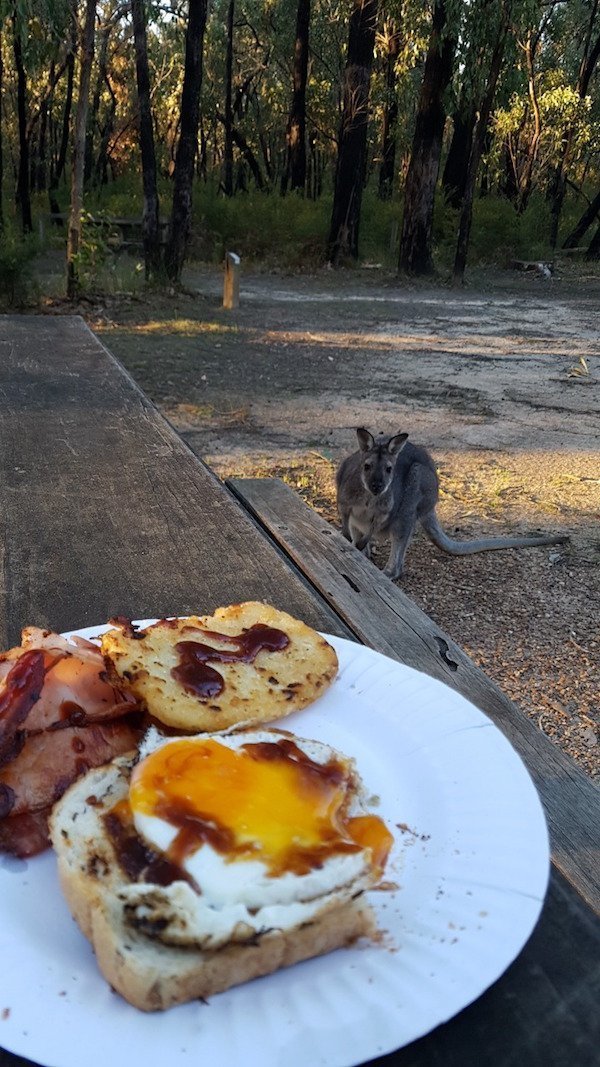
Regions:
[[0, 317, 600, 1067]]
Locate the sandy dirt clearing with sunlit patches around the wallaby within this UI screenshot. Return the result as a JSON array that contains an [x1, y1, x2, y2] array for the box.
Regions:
[[66, 264, 600, 776]]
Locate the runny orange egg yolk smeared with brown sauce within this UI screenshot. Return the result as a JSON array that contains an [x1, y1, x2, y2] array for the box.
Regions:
[[129, 737, 393, 876]]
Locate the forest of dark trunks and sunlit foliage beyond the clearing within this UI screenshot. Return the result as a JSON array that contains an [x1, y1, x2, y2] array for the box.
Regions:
[[0, 0, 600, 300]]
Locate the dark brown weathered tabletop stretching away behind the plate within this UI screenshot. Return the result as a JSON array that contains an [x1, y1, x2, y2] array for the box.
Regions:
[[0, 316, 347, 648]]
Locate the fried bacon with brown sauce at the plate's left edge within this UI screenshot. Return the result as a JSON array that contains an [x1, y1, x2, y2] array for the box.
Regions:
[[0, 626, 141, 856]]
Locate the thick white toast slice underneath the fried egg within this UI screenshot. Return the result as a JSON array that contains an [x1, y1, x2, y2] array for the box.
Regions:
[[50, 738, 375, 1012]]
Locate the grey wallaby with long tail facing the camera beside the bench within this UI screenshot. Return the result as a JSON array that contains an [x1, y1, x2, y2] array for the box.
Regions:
[[336, 429, 569, 578]]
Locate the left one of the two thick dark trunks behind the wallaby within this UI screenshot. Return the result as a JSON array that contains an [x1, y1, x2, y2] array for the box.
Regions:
[[328, 0, 377, 266]]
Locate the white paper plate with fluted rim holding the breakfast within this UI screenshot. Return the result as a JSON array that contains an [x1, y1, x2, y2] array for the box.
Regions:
[[0, 627, 549, 1067]]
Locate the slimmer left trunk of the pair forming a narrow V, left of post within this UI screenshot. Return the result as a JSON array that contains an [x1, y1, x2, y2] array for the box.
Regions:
[[131, 0, 161, 282]]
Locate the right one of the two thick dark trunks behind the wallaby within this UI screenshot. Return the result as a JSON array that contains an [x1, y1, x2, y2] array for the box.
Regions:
[[399, 0, 456, 274]]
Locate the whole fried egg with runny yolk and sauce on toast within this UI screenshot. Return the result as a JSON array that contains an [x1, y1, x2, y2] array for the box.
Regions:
[[123, 730, 393, 947]]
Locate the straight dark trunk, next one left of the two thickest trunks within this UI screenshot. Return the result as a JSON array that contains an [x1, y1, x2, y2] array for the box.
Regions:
[[281, 0, 311, 195]]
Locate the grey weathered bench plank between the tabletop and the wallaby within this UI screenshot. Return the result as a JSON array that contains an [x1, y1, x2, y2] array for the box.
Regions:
[[228, 478, 600, 909]]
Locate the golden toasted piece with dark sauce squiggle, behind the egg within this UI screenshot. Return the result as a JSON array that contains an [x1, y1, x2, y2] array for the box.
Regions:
[[102, 602, 337, 733]]
